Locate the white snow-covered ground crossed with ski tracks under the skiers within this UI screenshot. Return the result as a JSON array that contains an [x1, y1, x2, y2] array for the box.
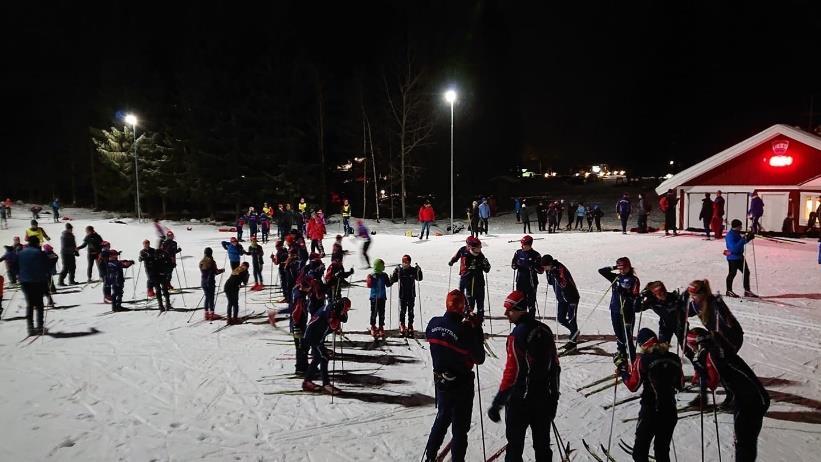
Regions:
[[0, 208, 821, 462]]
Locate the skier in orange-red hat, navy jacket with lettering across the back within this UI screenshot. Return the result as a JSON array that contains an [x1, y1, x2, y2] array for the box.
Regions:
[[423, 289, 485, 462]]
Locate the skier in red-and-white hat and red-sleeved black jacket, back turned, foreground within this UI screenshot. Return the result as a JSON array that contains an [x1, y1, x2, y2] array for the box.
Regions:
[[487, 291, 562, 461]]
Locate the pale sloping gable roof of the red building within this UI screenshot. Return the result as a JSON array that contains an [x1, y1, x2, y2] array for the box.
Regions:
[[656, 124, 821, 194]]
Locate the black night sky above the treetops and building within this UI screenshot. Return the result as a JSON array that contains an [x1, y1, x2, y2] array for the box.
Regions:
[[6, 1, 821, 203]]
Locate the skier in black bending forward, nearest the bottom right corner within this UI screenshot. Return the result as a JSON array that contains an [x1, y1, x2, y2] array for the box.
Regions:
[[687, 327, 770, 461]]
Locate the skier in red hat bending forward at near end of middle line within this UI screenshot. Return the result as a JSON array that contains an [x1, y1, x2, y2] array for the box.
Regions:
[[302, 297, 351, 395]]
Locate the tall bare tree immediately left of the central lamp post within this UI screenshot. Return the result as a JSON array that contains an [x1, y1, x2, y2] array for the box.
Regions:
[[382, 52, 433, 223]]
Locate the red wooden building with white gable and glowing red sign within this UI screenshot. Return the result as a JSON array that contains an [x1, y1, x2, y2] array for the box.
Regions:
[[656, 125, 821, 232]]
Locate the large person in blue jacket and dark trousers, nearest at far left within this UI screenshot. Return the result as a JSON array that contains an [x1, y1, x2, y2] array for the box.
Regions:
[[18, 236, 50, 336]]
